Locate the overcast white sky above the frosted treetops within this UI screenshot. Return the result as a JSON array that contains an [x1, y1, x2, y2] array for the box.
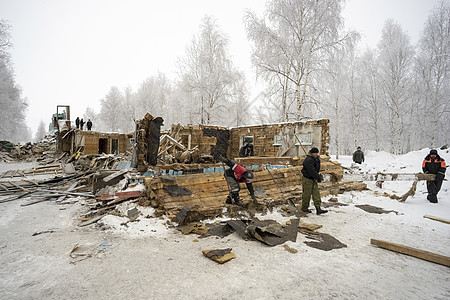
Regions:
[[0, 0, 438, 137]]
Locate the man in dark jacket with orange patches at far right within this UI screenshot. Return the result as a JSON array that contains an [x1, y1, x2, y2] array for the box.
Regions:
[[422, 149, 447, 203]]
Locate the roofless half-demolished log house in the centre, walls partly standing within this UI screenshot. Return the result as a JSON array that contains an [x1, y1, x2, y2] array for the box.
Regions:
[[131, 119, 366, 220]]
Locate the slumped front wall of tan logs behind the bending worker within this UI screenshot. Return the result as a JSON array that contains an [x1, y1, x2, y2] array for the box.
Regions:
[[144, 156, 366, 220]]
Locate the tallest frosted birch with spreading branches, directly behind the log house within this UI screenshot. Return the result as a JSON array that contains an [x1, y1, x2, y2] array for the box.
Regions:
[[245, 0, 351, 120]]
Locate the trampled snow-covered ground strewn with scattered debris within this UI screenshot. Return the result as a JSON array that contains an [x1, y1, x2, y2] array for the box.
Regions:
[[0, 149, 450, 299]]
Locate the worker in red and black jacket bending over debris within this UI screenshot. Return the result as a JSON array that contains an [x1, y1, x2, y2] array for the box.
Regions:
[[224, 159, 258, 206]]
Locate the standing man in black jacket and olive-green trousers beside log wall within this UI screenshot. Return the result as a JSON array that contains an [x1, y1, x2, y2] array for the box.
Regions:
[[302, 147, 328, 215]]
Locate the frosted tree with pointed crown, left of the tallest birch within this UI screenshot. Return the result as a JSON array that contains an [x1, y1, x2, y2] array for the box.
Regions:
[[178, 16, 248, 124]]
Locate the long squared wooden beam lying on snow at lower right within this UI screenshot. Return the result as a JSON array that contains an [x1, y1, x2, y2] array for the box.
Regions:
[[370, 239, 450, 267]]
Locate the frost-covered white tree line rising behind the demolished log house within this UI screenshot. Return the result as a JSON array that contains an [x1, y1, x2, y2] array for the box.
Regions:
[[89, 0, 450, 154]]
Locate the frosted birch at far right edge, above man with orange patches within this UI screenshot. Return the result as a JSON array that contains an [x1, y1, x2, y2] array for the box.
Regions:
[[415, 1, 450, 148]]
